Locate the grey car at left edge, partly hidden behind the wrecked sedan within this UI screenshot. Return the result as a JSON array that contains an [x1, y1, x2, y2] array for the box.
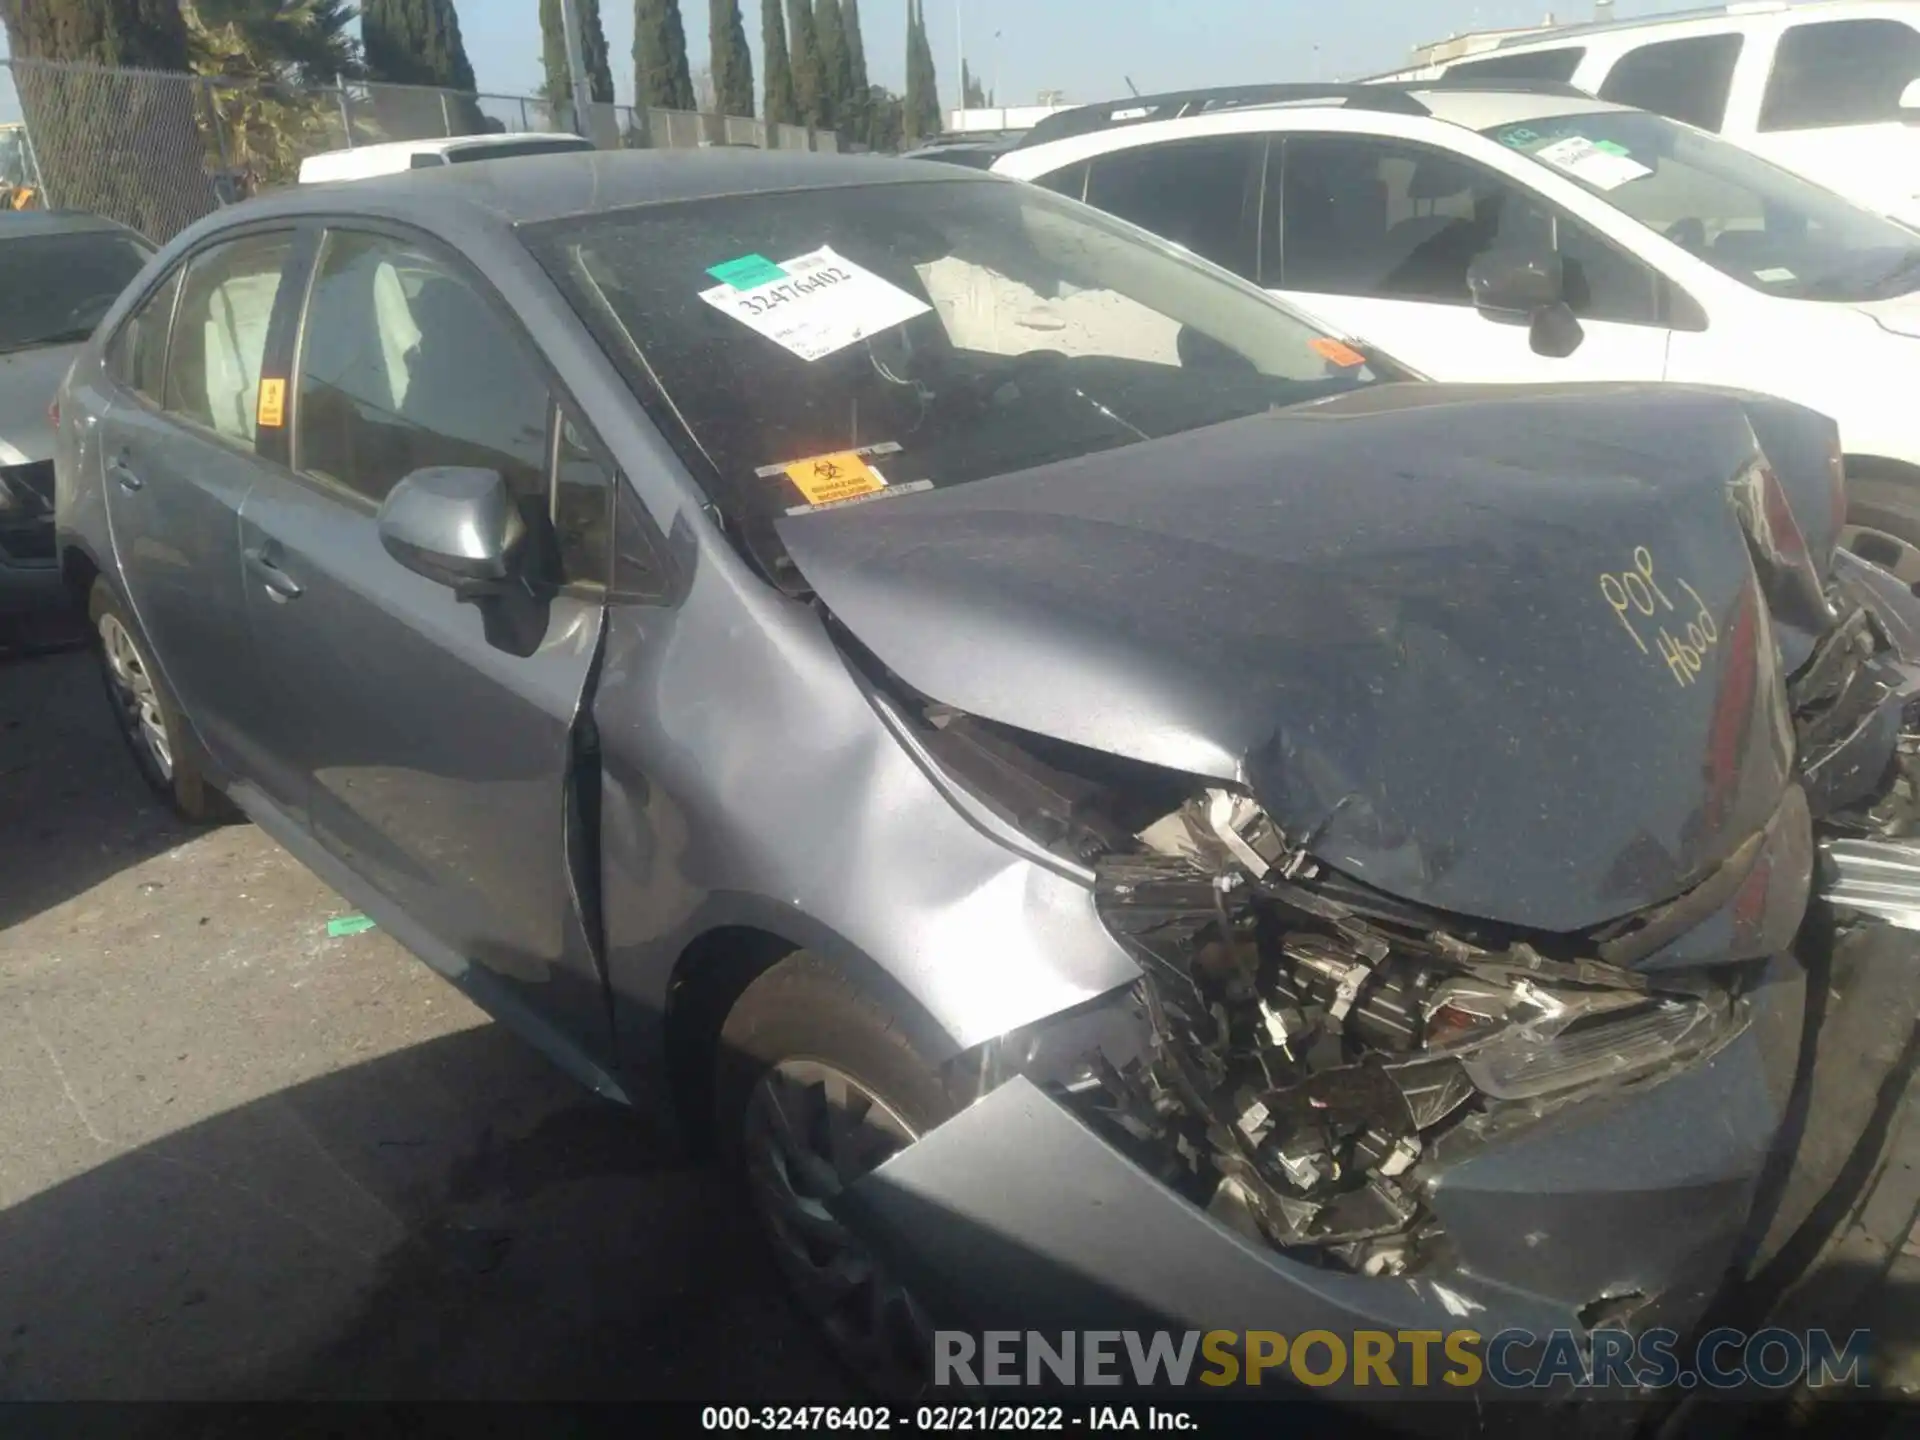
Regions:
[[0, 211, 154, 624]]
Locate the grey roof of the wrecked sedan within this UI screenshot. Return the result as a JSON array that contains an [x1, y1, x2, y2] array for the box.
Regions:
[[214, 148, 998, 230]]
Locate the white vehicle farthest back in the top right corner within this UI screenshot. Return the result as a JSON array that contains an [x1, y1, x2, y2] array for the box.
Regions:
[[1380, 0, 1920, 225]]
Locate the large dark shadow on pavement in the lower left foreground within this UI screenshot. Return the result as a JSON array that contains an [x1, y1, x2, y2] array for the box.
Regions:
[[0, 1025, 852, 1404]]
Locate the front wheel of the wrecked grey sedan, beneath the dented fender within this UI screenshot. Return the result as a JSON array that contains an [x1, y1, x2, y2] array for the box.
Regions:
[[716, 950, 956, 1400]]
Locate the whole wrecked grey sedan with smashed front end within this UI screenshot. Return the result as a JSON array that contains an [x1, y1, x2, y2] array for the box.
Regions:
[[60, 152, 1920, 1413]]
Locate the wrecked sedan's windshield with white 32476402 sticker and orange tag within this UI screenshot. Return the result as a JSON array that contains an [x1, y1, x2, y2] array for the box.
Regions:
[[524, 180, 1407, 563]]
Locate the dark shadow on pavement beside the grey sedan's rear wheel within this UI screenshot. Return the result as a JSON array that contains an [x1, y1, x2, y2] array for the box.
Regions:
[[0, 649, 194, 929]]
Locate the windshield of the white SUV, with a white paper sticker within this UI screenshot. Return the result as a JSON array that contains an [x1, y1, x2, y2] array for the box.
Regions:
[[1484, 109, 1920, 301]]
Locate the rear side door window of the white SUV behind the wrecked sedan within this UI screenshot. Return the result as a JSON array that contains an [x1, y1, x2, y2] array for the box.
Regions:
[[1085, 134, 1261, 276]]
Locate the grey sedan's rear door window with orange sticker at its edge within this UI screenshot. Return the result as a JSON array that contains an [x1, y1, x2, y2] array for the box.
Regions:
[[165, 230, 294, 449]]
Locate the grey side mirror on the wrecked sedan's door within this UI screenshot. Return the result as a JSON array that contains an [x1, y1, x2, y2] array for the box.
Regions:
[[378, 465, 526, 599]]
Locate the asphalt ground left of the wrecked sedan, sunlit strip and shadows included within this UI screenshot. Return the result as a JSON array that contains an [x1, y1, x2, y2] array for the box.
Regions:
[[0, 653, 851, 1402]]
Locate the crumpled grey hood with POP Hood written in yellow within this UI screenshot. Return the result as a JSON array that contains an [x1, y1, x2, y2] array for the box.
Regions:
[[780, 384, 1841, 931]]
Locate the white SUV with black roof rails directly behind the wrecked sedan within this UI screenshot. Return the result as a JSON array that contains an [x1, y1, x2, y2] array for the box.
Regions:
[[993, 83, 1920, 564]]
